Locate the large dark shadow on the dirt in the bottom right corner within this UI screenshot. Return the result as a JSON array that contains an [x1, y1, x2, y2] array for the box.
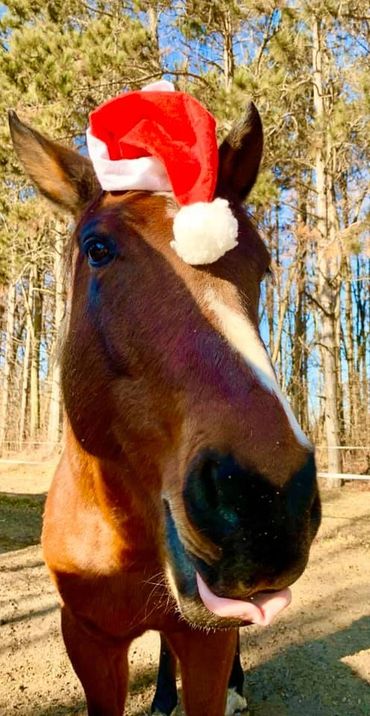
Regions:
[[246, 616, 370, 716]]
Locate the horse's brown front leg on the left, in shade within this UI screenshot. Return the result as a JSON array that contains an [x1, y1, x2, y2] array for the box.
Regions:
[[62, 607, 129, 716]]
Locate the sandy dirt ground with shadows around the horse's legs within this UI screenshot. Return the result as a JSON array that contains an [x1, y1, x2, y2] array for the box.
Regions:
[[0, 463, 370, 716]]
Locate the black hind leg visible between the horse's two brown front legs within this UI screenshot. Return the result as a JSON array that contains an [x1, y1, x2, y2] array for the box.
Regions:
[[150, 633, 177, 716]]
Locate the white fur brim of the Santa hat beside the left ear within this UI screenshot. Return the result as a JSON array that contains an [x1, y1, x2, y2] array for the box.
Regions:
[[86, 129, 172, 191]]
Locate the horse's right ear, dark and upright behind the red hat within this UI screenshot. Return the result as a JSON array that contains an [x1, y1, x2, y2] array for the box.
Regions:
[[216, 102, 263, 201]]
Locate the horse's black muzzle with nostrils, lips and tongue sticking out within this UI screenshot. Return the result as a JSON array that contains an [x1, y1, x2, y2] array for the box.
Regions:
[[165, 452, 320, 628]]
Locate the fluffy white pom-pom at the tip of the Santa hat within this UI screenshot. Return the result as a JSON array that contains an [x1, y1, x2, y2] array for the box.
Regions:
[[171, 199, 238, 266]]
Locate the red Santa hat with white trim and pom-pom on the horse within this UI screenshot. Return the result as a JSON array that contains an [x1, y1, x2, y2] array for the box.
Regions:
[[87, 80, 238, 265]]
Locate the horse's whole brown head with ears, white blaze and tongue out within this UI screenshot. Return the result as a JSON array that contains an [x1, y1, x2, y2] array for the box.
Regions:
[[11, 105, 320, 627]]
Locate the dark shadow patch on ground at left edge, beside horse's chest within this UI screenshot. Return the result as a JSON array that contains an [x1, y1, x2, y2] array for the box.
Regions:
[[0, 492, 46, 554]]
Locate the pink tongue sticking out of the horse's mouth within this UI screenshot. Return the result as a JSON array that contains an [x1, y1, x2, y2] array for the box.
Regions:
[[197, 573, 292, 626]]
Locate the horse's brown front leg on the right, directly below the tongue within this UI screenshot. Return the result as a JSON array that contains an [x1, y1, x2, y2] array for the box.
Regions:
[[166, 628, 237, 716]]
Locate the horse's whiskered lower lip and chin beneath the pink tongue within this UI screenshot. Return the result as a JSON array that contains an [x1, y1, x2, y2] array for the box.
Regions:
[[165, 502, 246, 630]]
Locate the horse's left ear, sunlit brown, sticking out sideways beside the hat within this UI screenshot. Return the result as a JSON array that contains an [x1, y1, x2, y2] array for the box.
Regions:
[[9, 111, 99, 214]]
